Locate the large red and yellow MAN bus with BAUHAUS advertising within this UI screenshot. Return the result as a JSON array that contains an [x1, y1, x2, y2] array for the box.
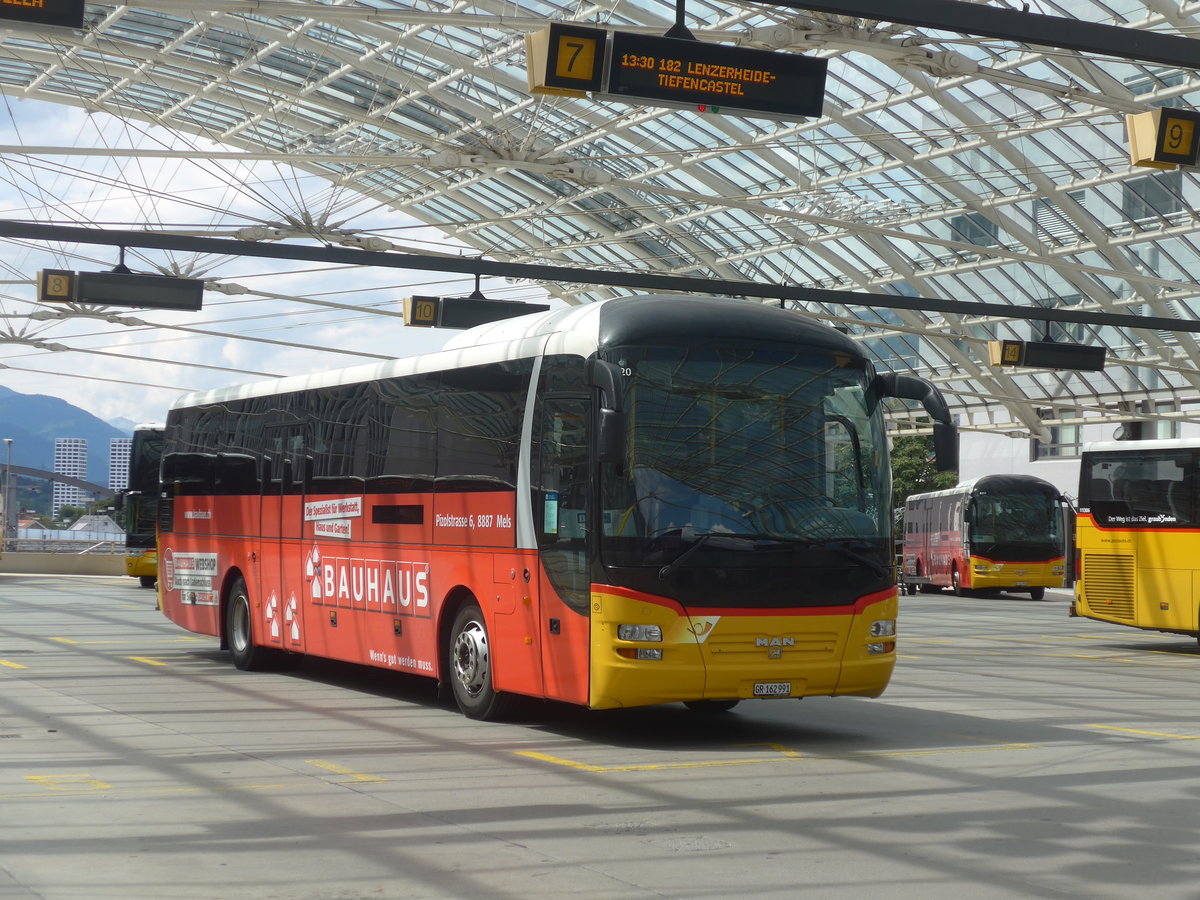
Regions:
[[160, 296, 956, 718]]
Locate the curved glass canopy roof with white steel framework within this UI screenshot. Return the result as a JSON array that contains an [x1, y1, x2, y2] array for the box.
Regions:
[[0, 0, 1200, 434]]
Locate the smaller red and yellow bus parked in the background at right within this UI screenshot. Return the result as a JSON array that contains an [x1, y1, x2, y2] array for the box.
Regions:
[[901, 475, 1069, 600]]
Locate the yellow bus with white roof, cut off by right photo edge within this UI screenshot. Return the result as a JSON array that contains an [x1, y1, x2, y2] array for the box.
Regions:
[[1072, 439, 1200, 637]]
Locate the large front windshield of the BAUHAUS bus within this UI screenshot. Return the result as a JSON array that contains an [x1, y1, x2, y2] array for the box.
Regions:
[[602, 347, 889, 566]]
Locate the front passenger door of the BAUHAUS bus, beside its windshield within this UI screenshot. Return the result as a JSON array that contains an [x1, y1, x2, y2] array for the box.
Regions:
[[533, 396, 592, 703]]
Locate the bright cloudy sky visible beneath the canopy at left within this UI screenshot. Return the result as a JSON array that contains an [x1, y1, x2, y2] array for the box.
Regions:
[[0, 96, 556, 422]]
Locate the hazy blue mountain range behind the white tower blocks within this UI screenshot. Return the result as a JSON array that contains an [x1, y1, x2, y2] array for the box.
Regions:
[[0, 385, 133, 485]]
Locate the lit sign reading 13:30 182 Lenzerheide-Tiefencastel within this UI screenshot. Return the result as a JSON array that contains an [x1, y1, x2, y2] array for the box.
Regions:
[[607, 31, 828, 118]]
